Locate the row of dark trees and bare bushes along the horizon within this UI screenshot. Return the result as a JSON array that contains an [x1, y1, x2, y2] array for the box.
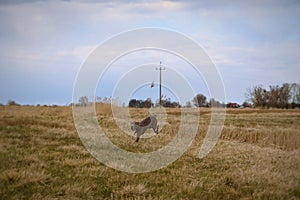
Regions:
[[0, 83, 300, 108]]
